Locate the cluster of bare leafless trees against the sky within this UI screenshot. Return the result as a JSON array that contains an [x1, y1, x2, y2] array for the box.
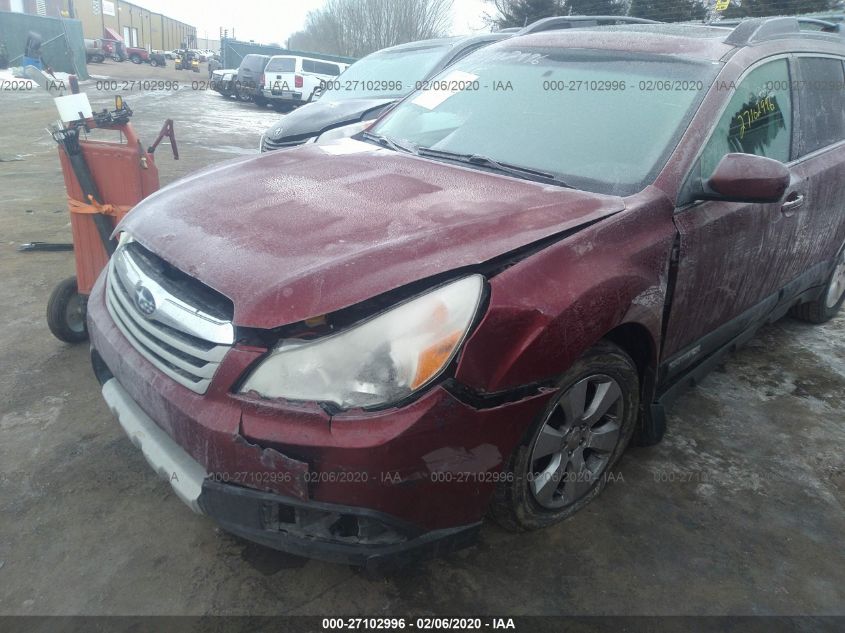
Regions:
[[288, 0, 453, 57]]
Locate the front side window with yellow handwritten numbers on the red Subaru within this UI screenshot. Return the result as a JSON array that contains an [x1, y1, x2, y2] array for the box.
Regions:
[[701, 59, 792, 179]]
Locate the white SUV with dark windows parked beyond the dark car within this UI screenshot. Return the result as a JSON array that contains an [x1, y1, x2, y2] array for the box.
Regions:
[[261, 55, 348, 109]]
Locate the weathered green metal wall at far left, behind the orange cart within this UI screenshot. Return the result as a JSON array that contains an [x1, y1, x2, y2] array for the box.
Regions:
[[0, 11, 88, 79]]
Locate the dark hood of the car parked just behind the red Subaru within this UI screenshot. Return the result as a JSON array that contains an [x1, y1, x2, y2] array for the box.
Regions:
[[265, 99, 396, 141]]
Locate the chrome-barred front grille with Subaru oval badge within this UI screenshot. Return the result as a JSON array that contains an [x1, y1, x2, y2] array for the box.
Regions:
[[106, 242, 234, 394]]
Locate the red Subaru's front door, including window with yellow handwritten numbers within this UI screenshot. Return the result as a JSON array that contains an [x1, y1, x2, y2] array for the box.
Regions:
[[662, 56, 807, 372]]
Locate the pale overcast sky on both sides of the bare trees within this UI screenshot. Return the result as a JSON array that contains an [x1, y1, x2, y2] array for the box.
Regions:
[[133, 0, 492, 43]]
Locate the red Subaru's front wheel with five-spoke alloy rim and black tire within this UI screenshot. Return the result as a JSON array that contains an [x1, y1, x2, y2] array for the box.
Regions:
[[490, 341, 639, 532]]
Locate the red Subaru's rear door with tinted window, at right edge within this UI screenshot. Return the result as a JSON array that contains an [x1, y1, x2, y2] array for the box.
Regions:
[[793, 54, 845, 284]]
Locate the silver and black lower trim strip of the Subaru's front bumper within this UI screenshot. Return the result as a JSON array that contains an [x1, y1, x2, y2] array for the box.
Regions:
[[96, 377, 481, 571]]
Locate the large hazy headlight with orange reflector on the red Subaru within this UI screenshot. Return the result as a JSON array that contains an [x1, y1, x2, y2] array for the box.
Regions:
[[241, 275, 484, 409]]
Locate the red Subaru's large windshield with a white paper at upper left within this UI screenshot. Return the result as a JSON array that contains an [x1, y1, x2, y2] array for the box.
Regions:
[[372, 47, 718, 195]]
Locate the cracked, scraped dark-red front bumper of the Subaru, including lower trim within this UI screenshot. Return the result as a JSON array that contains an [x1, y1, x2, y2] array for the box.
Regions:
[[88, 277, 550, 568]]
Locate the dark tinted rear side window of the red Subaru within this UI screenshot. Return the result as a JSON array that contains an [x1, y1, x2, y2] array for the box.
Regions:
[[795, 57, 845, 156]]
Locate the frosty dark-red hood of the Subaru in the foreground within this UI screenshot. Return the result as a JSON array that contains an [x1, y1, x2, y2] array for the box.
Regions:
[[118, 139, 625, 328]]
